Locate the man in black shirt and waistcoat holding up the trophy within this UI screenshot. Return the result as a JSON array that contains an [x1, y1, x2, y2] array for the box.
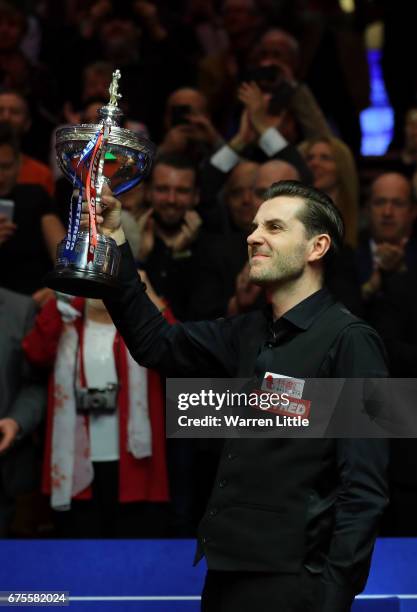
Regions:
[[49, 69, 387, 612]]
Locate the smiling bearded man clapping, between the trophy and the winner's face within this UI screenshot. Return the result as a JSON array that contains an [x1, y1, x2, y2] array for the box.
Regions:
[[138, 153, 216, 537]]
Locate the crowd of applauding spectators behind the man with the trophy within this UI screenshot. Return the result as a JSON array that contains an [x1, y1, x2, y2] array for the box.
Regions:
[[0, 0, 417, 537]]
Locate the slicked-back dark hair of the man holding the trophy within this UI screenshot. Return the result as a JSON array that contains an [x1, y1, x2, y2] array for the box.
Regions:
[[264, 181, 345, 259]]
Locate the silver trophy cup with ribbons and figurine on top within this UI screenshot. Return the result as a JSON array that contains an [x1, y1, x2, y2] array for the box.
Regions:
[[47, 70, 155, 298]]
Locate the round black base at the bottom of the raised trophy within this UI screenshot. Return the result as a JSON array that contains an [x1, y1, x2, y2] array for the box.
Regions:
[[45, 267, 119, 299]]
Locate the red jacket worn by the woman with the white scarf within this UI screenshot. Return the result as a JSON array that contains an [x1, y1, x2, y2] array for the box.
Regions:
[[23, 298, 171, 502]]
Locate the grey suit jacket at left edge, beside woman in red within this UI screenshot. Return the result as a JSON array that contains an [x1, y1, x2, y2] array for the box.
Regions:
[[0, 288, 46, 496]]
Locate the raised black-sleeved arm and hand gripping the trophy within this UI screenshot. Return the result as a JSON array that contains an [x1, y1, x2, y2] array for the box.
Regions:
[[82, 187, 236, 377]]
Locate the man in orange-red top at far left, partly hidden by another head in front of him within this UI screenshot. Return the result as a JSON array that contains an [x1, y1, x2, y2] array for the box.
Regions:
[[0, 90, 54, 196]]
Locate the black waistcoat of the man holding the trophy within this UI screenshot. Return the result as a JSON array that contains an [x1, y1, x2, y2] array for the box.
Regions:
[[195, 303, 357, 572]]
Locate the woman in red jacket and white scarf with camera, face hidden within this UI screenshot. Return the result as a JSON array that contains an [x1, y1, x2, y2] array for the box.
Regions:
[[23, 280, 172, 538]]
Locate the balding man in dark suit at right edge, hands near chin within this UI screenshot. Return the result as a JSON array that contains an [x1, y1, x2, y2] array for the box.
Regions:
[[358, 173, 417, 536]]
